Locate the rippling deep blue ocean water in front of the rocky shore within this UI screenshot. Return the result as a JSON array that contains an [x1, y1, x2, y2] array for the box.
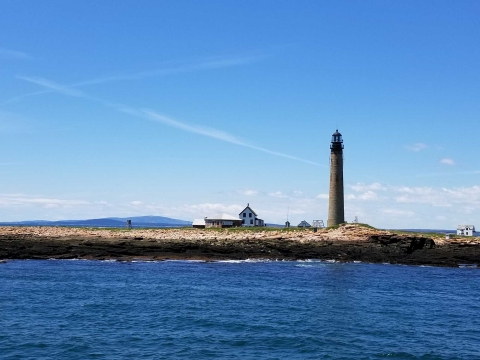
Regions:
[[0, 260, 480, 359]]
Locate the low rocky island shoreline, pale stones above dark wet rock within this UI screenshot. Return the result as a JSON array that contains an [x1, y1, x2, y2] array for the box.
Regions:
[[0, 224, 480, 267]]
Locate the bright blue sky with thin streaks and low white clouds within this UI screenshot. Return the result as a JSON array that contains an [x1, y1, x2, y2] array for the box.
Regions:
[[0, 0, 480, 228]]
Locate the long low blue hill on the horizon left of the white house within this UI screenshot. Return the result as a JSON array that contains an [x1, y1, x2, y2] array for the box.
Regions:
[[0, 216, 192, 228]]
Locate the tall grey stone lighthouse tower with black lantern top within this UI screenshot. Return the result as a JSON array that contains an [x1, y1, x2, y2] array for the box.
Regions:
[[327, 130, 345, 226]]
